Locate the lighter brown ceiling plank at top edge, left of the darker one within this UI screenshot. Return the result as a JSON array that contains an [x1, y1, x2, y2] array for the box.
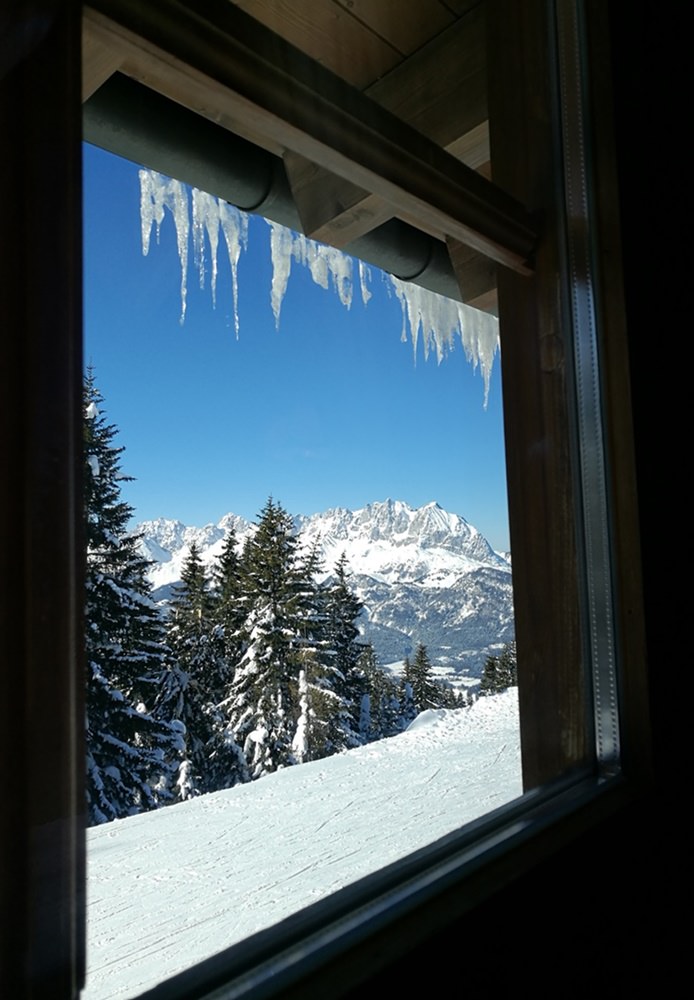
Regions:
[[233, 0, 402, 90]]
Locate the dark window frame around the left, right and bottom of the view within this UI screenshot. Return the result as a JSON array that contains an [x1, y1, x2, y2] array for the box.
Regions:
[[0, 0, 650, 997]]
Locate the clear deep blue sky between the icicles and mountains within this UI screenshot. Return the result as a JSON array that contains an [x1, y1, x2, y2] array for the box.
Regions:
[[84, 145, 508, 549]]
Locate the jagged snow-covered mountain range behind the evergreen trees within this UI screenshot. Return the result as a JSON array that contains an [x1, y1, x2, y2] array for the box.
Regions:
[[136, 500, 513, 676]]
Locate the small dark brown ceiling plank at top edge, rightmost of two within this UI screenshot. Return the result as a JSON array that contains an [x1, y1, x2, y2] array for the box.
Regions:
[[333, 0, 455, 56]]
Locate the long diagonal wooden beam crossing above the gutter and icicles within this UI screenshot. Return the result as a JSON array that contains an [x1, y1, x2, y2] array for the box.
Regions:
[[85, 0, 536, 274]]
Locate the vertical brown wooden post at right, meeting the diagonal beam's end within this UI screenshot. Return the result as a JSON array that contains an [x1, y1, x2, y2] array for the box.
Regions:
[[487, 0, 593, 789]]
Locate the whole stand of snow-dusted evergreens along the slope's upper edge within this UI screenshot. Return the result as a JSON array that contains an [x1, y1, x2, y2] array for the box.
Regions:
[[84, 370, 516, 825]]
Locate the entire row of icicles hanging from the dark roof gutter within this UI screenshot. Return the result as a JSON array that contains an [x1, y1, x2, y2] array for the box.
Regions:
[[140, 169, 499, 406]]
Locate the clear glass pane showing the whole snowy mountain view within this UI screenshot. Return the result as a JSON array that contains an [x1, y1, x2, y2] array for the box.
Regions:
[[80, 146, 522, 1000]]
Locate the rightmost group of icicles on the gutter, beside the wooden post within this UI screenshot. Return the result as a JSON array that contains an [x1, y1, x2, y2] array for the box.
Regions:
[[390, 275, 499, 409]]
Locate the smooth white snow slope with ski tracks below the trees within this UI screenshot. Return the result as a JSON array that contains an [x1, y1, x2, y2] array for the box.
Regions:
[[83, 689, 522, 1000]]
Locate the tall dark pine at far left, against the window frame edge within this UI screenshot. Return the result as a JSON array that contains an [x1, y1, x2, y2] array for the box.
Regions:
[[84, 370, 181, 823]]
